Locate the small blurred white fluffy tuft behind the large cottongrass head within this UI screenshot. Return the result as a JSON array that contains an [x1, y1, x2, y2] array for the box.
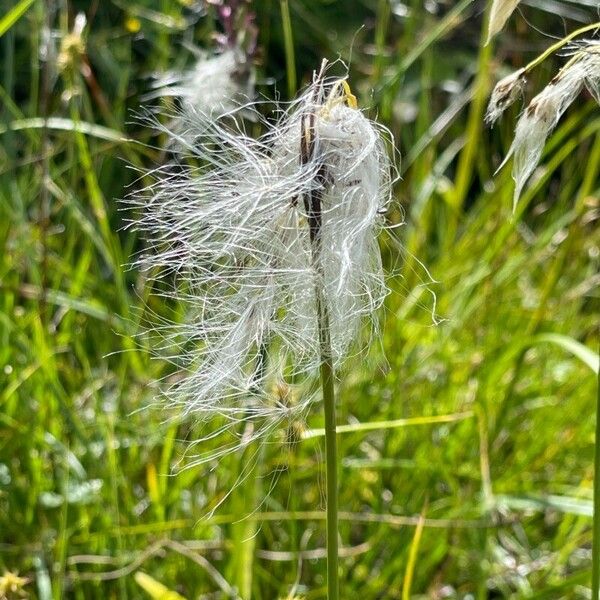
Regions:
[[146, 47, 255, 117]]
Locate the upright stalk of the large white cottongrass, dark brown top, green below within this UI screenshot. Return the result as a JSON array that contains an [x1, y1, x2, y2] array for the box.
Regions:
[[300, 61, 339, 600]]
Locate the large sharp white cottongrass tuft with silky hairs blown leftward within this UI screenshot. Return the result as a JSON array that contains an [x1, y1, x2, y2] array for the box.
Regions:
[[130, 67, 392, 462]]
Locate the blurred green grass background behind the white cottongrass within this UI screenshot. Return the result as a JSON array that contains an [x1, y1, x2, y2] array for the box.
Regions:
[[0, 0, 600, 600]]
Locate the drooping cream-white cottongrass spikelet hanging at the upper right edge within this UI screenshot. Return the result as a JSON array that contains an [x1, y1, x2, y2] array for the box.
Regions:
[[500, 43, 600, 210]]
